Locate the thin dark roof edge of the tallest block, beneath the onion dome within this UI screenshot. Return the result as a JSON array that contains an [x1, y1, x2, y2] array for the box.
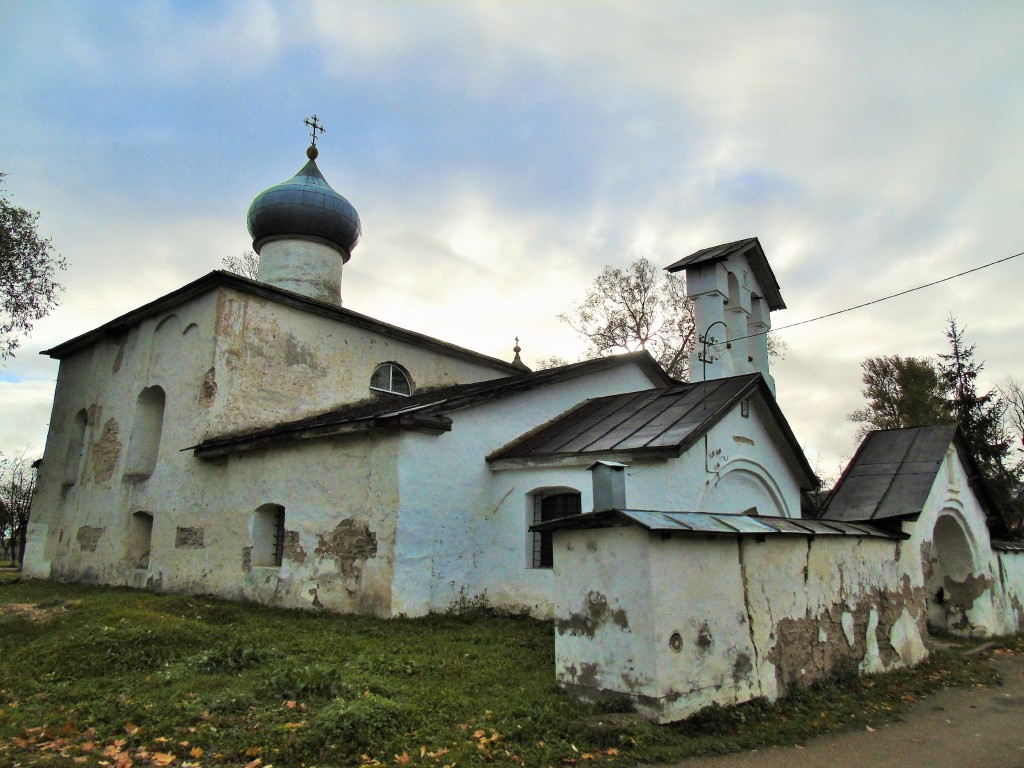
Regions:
[[40, 269, 522, 374]]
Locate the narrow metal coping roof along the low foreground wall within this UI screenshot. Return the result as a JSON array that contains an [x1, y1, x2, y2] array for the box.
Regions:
[[529, 509, 906, 539]]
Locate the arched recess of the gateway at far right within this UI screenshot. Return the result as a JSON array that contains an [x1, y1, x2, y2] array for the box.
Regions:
[[928, 512, 984, 632]]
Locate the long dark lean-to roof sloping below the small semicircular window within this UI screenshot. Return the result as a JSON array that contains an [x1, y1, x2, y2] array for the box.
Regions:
[[191, 351, 673, 458]]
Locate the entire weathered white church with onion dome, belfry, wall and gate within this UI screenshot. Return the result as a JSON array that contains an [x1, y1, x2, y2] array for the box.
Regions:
[[25, 141, 1024, 721]]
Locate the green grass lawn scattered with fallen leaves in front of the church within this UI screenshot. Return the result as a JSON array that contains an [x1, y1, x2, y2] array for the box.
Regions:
[[0, 583, 1024, 768]]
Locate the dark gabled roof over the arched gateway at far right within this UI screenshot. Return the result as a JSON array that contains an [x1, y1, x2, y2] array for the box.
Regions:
[[819, 424, 1004, 530]]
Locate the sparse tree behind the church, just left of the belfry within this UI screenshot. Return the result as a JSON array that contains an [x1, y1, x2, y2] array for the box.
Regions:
[[558, 258, 696, 379]]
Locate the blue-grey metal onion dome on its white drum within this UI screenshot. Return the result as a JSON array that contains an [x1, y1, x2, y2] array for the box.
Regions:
[[248, 146, 362, 261]]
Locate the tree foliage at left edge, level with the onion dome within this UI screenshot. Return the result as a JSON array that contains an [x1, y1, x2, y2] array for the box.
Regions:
[[0, 173, 66, 362]]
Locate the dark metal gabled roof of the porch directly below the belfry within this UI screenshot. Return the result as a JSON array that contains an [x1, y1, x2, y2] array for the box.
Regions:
[[487, 373, 816, 485]]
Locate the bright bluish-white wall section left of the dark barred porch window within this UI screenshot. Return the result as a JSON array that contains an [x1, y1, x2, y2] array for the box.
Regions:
[[392, 362, 654, 616]]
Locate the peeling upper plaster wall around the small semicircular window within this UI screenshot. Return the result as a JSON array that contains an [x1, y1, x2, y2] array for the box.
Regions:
[[203, 288, 520, 437]]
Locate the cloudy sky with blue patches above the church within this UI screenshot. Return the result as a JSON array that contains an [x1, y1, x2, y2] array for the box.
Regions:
[[0, 0, 1024, 474]]
